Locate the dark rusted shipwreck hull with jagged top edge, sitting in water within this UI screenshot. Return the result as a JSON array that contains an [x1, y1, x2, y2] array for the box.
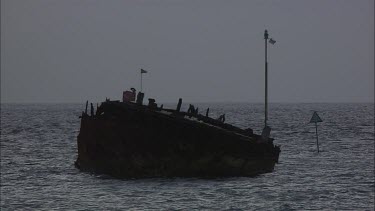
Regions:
[[75, 92, 280, 178]]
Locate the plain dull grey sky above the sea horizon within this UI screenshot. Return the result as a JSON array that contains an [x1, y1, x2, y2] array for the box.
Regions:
[[1, 0, 374, 103]]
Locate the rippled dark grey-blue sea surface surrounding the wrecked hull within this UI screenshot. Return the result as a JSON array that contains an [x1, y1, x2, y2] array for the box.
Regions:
[[0, 103, 375, 211]]
